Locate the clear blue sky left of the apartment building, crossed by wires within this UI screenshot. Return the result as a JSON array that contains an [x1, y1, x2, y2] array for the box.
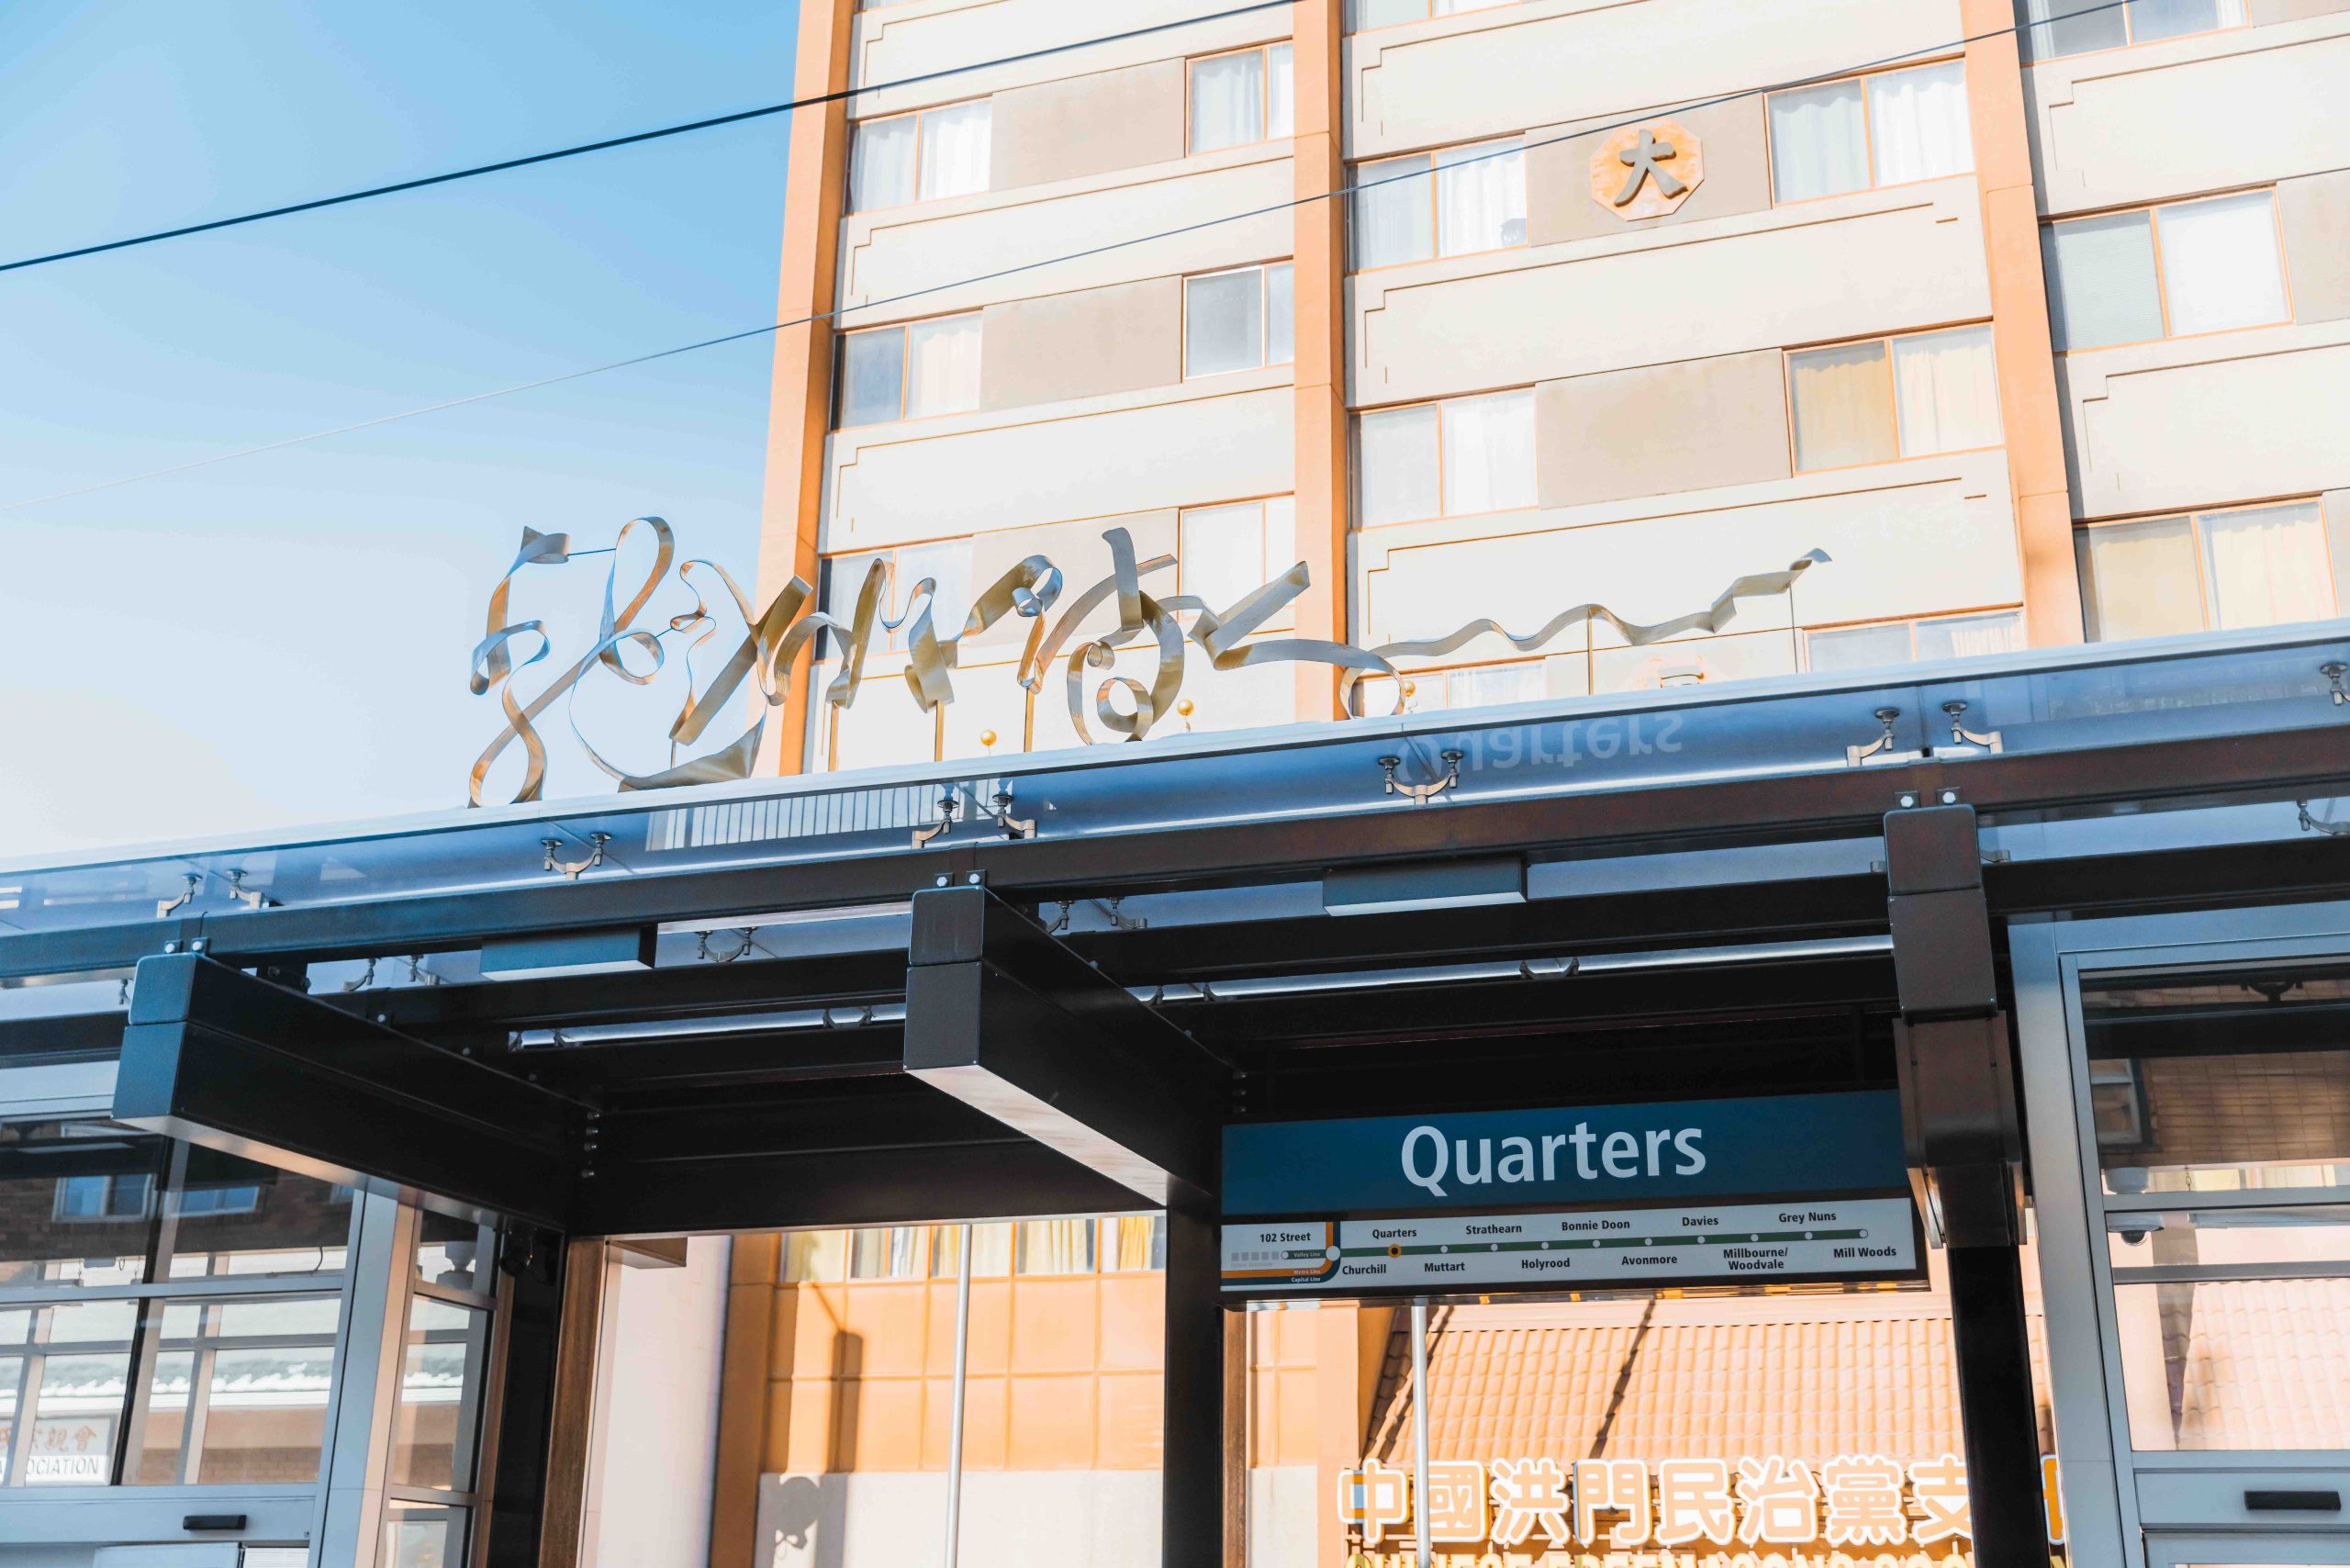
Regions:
[[0, 0, 794, 858]]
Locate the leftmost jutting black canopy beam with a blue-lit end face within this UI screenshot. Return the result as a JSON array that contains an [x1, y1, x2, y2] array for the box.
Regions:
[[113, 952, 578, 1223]]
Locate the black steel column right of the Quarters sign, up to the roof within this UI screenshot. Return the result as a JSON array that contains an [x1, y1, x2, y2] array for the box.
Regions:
[[1885, 804, 2047, 1568]]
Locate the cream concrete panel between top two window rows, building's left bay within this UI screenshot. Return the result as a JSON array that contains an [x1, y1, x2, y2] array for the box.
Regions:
[[841, 151, 1295, 327]]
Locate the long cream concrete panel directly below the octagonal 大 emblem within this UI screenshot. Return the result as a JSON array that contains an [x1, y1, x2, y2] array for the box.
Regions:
[[1354, 176, 1990, 407]]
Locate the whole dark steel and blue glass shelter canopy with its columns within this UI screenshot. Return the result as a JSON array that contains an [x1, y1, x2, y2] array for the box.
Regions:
[[0, 628, 2350, 1563]]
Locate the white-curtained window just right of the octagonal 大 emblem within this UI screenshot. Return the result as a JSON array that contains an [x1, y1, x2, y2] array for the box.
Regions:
[[1770, 59, 1974, 202]]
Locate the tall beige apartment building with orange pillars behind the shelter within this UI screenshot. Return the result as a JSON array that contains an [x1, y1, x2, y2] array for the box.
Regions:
[[761, 0, 2350, 768]]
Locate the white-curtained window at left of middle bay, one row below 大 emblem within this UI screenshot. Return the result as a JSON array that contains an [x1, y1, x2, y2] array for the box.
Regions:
[[1356, 390, 1537, 527]]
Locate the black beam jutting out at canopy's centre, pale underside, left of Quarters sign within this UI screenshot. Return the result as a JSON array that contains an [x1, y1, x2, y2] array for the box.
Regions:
[[905, 886, 1225, 1204]]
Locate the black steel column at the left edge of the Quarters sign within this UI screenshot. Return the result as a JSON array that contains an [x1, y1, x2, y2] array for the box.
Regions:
[[1158, 1194, 1225, 1568]]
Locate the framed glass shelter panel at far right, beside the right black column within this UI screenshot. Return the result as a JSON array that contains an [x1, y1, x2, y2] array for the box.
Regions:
[[2080, 959, 2350, 1453]]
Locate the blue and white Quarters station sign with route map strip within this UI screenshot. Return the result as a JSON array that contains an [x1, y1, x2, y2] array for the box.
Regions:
[[1222, 1091, 1920, 1295]]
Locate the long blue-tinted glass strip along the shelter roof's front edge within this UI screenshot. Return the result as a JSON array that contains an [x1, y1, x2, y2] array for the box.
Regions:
[[0, 623, 2350, 938]]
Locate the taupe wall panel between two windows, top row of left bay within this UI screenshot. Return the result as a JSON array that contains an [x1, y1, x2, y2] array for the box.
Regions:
[[990, 59, 1184, 190]]
